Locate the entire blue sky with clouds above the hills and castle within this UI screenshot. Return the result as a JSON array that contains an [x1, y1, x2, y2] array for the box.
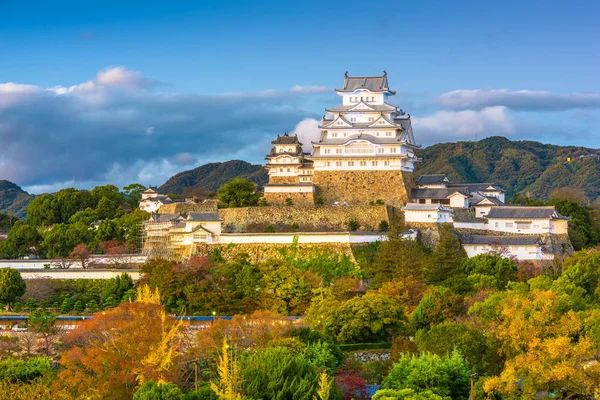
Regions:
[[0, 0, 600, 192]]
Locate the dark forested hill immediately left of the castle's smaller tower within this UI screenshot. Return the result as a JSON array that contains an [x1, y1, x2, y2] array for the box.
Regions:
[[159, 160, 269, 195]]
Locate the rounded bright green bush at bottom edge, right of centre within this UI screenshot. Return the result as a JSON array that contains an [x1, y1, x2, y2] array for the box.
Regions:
[[382, 352, 472, 400]]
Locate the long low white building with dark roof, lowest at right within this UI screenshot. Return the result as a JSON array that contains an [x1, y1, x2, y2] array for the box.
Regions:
[[461, 235, 554, 261]]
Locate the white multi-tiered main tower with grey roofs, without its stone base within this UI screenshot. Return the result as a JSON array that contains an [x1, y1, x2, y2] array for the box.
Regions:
[[309, 71, 420, 172]]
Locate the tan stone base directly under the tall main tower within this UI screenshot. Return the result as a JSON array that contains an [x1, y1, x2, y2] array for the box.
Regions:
[[313, 171, 414, 206]]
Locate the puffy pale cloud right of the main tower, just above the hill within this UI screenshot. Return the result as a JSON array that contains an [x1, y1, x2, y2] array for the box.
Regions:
[[412, 106, 515, 144]]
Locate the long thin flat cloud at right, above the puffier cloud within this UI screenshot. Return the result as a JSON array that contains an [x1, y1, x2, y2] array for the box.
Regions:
[[438, 89, 600, 111]]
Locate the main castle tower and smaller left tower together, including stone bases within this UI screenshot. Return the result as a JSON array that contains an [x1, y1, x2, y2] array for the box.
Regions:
[[265, 71, 420, 204]]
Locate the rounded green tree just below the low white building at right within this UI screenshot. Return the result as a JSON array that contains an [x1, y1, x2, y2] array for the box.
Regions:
[[463, 254, 518, 290]]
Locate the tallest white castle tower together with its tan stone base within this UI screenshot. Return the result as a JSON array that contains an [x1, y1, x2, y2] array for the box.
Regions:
[[306, 71, 420, 205]]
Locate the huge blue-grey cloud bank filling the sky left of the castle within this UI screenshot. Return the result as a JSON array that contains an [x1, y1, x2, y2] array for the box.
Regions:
[[0, 67, 318, 192]]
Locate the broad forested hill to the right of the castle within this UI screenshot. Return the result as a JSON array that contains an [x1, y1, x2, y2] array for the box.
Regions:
[[415, 136, 600, 201]]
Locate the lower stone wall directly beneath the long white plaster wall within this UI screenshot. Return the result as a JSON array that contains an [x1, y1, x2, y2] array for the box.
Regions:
[[192, 243, 356, 263]]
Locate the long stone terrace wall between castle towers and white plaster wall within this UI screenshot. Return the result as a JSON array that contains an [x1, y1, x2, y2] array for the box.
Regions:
[[219, 205, 390, 233]]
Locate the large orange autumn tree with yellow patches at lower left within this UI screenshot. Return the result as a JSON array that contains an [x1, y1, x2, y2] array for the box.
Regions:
[[57, 288, 181, 399]]
